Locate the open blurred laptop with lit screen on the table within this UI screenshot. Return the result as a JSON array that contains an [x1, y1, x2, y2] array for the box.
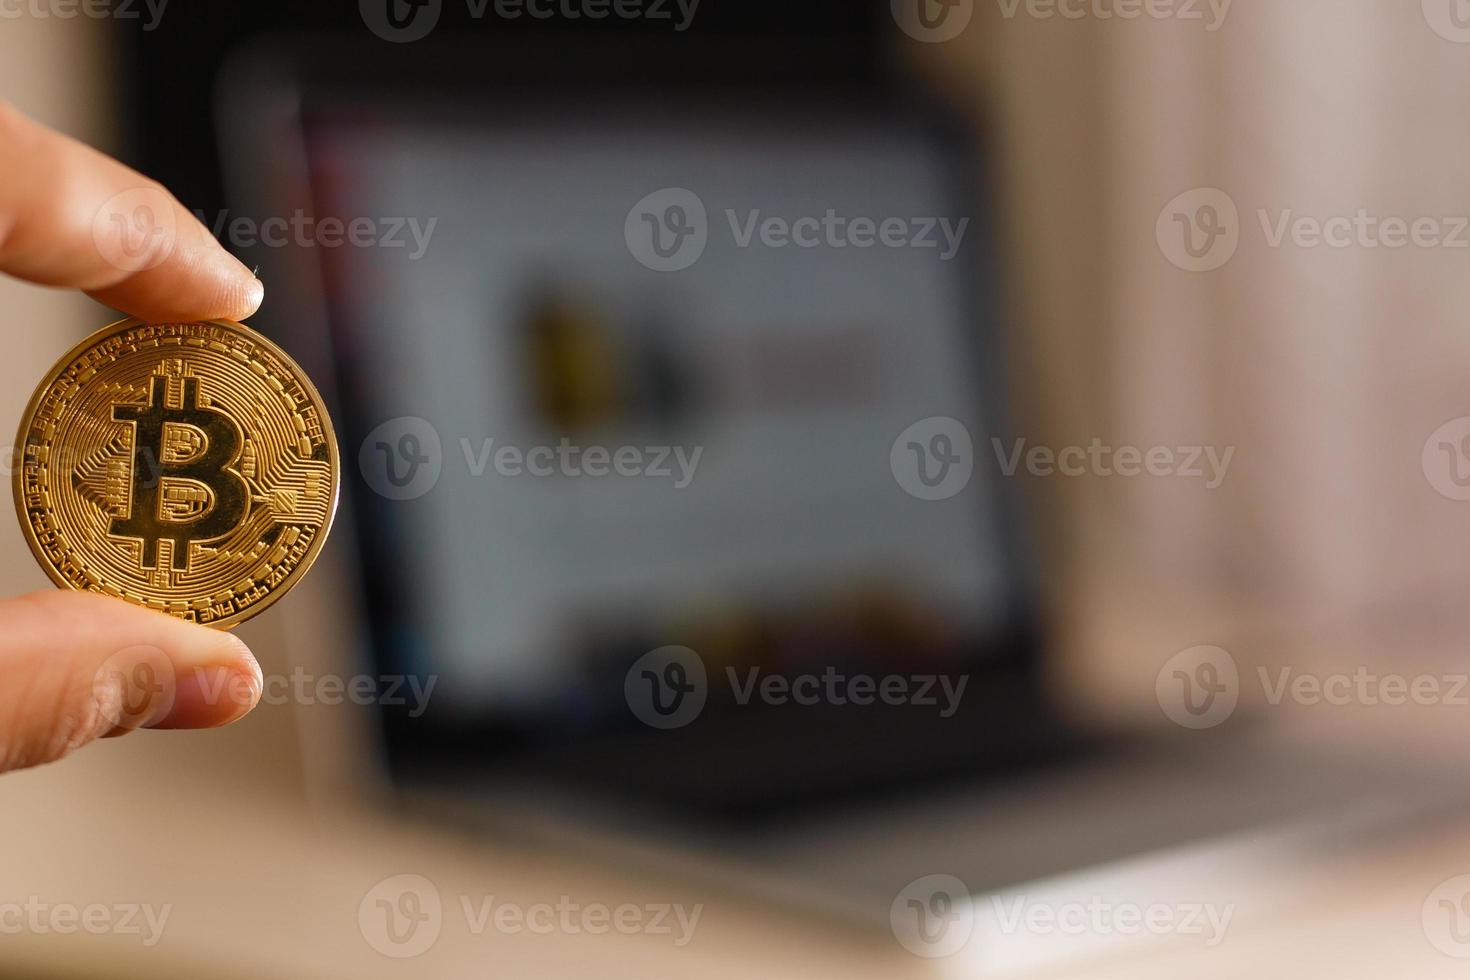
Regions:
[[218, 34, 1458, 963]]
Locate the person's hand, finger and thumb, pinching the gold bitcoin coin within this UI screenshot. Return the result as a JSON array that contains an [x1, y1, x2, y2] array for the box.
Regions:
[[0, 101, 265, 773]]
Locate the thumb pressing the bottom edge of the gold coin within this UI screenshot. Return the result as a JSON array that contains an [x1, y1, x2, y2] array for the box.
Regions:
[[0, 591, 263, 773]]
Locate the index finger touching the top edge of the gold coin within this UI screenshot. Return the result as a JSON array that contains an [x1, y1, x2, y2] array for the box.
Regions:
[[0, 101, 265, 322]]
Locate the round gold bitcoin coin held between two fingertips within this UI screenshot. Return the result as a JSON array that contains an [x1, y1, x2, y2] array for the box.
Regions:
[[15, 320, 340, 629]]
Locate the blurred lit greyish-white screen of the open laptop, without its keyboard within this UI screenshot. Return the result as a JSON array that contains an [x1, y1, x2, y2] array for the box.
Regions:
[[309, 113, 1007, 713]]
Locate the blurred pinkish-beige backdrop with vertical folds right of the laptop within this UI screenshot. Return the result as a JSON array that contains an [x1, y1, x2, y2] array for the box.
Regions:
[[910, 0, 1470, 719]]
